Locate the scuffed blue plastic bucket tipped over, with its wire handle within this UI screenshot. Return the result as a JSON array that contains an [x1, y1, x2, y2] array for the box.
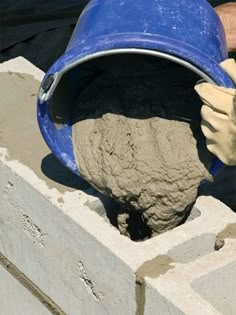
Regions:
[[38, 0, 234, 176]]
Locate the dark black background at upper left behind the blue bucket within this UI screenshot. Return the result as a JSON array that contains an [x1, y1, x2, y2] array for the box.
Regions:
[[0, 0, 232, 71]]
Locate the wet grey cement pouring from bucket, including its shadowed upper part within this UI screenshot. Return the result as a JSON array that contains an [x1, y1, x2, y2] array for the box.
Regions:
[[73, 58, 211, 236]]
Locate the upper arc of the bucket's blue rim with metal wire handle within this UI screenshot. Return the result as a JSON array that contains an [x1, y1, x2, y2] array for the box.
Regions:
[[38, 33, 234, 103]]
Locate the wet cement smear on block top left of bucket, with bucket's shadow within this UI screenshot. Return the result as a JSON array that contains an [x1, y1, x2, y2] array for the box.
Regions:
[[0, 70, 89, 193]]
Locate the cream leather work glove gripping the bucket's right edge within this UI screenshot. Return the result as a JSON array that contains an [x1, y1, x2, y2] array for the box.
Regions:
[[195, 59, 236, 165]]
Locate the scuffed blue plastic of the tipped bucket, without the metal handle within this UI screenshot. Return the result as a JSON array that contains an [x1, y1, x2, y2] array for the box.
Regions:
[[38, 0, 234, 179]]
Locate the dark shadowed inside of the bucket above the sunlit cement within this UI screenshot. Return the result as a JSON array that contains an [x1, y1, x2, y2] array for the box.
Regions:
[[49, 53, 212, 169]]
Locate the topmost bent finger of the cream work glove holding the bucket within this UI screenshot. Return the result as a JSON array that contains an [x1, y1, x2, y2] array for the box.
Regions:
[[195, 83, 236, 116]]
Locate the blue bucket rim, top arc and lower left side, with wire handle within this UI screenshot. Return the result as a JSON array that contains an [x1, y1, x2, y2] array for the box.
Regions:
[[38, 34, 234, 176]]
